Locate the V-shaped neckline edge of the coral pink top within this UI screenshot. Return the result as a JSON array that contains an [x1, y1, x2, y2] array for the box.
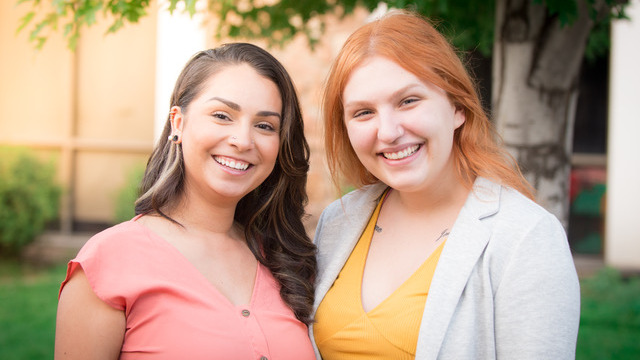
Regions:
[[130, 217, 263, 309]]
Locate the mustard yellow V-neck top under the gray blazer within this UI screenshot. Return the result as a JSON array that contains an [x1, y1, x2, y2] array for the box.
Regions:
[[313, 194, 444, 360]]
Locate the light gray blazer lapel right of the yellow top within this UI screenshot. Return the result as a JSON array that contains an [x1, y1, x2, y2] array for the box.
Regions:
[[416, 178, 500, 360]]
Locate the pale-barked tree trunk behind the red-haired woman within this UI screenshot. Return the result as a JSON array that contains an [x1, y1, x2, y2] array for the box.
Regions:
[[492, 0, 593, 228]]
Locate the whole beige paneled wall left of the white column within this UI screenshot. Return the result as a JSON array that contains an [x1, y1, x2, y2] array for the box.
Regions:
[[0, 1, 156, 230]]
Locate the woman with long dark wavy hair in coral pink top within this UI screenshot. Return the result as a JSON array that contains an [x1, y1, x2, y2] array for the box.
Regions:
[[55, 43, 316, 360]]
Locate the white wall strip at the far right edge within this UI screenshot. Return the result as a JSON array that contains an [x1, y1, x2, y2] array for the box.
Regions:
[[604, 0, 640, 271]]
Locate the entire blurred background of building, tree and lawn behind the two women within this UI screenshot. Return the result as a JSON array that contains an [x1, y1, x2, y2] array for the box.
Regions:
[[0, 0, 640, 359]]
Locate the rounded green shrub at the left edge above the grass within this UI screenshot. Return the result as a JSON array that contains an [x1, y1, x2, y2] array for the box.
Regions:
[[0, 146, 61, 256]]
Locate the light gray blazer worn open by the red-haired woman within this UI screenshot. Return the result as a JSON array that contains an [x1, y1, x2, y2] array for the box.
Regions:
[[309, 178, 580, 360]]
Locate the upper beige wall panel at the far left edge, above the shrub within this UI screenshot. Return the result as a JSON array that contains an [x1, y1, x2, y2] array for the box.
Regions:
[[0, 1, 73, 143]]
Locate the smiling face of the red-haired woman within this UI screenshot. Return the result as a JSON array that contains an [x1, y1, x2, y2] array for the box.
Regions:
[[343, 56, 465, 192]]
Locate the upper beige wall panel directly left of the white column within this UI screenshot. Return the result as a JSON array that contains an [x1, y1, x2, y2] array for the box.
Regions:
[[77, 16, 155, 142]]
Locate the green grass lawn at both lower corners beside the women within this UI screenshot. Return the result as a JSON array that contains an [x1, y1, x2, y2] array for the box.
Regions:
[[0, 259, 640, 360]]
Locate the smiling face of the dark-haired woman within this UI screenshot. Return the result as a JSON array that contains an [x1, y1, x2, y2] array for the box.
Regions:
[[171, 64, 282, 201]]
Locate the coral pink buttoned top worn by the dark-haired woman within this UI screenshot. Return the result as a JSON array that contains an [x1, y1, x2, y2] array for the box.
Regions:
[[61, 220, 314, 360]]
